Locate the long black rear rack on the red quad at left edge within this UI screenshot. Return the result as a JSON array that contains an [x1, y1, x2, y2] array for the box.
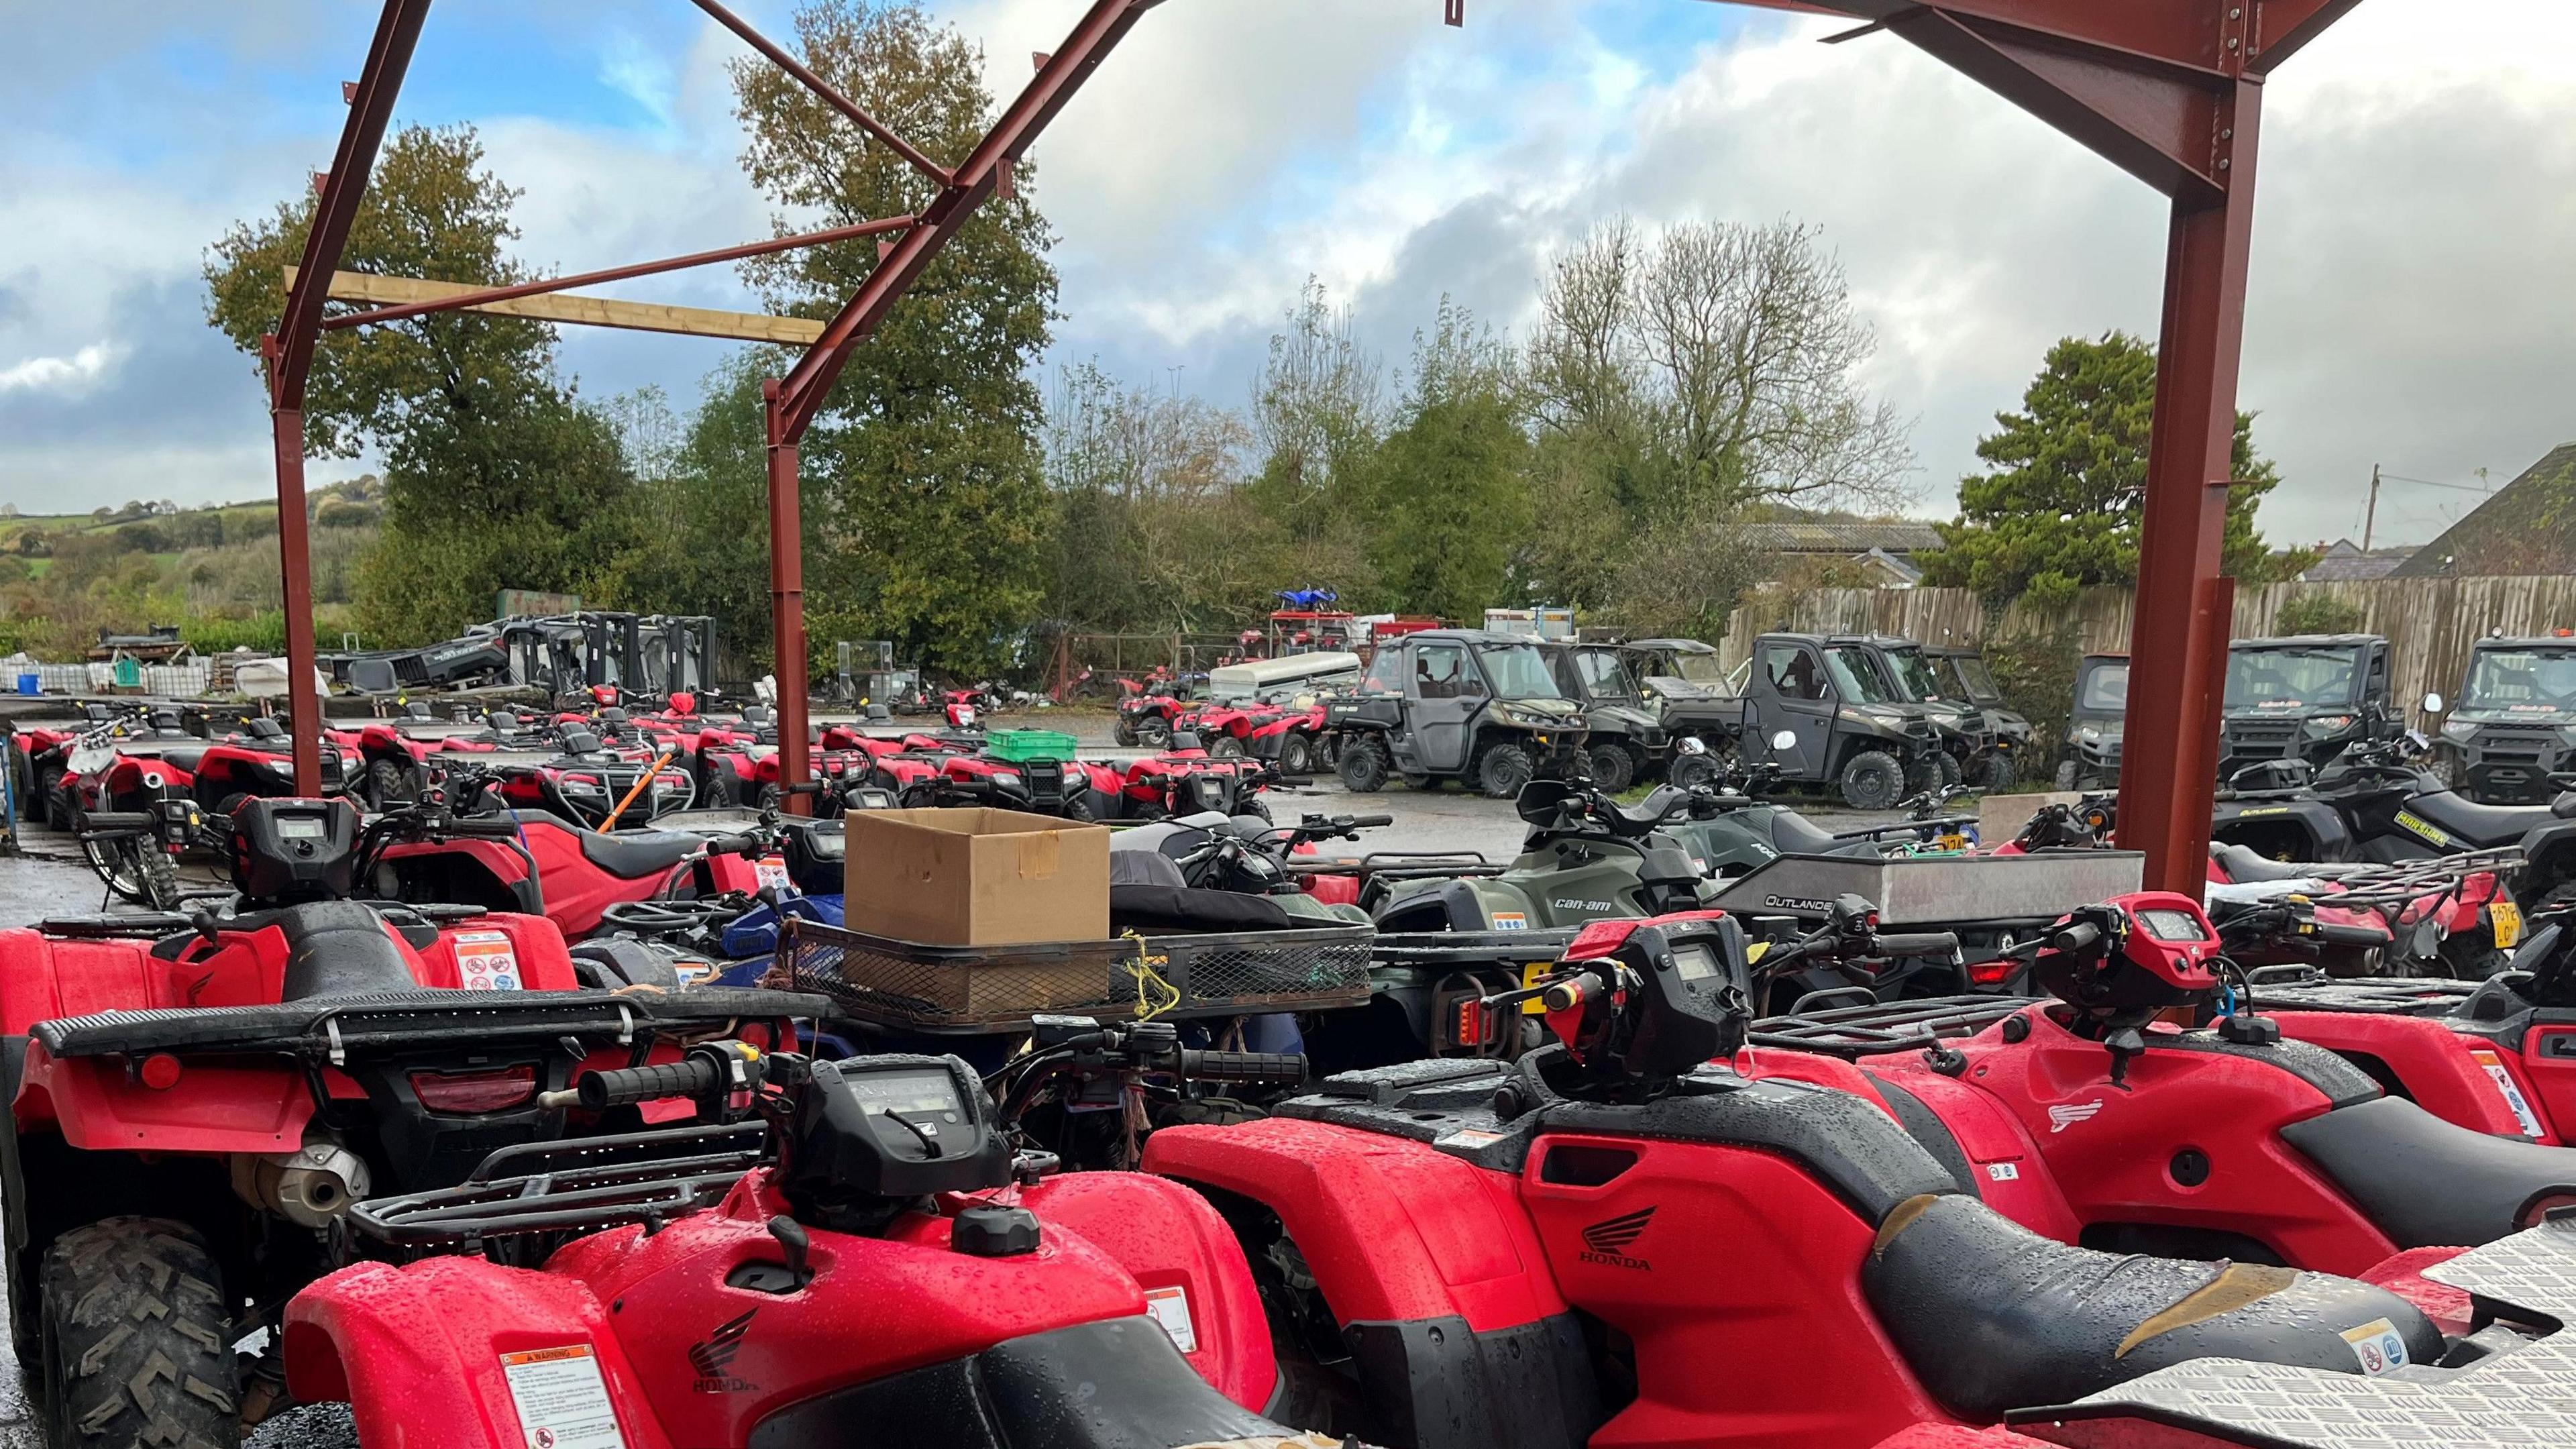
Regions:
[[28, 987, 832, 1065]]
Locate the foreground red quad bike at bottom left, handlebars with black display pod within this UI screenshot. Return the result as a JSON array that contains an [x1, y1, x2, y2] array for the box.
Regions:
[[269, 1042, 1358, 1449]]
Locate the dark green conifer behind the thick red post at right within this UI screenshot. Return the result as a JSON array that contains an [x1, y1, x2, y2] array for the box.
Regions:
[[1924, 333, 2303, 606]]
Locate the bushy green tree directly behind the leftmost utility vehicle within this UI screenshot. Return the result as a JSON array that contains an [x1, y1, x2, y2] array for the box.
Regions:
[[1371, 297, 1530, 619]]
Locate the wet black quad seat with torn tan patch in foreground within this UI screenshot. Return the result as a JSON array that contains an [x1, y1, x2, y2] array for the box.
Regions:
[[1860, 1194, 2445, 1418]]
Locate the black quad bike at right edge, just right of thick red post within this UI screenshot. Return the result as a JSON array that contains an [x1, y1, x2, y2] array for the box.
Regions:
[[2210, 740, 2576, 910]]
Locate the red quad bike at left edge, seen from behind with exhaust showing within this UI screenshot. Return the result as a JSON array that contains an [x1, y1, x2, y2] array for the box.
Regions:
[[0, 799, 824, 1449]]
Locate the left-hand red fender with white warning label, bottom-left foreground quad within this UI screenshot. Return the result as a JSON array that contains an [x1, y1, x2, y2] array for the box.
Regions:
[[283, 1258, 672, 1449]]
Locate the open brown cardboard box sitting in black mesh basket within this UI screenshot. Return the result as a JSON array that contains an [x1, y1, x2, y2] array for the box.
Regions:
[[843, 810, 1110, 947]]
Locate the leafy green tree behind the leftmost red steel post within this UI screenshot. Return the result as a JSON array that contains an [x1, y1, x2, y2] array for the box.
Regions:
[[206, 126, 636, 639]]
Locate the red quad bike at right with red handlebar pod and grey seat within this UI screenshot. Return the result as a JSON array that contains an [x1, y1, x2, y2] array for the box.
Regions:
[[1744, 892, 2576, 1284]]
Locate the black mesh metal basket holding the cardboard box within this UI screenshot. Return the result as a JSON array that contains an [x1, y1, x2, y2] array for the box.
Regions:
[[778, 918, 1376, 1031]]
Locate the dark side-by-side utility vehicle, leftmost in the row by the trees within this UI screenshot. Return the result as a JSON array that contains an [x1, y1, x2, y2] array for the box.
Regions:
[[1324, 629, 1585, 799]]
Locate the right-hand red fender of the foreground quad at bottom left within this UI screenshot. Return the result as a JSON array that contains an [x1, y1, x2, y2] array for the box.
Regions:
[[1020, 1173, 1278, 1413]]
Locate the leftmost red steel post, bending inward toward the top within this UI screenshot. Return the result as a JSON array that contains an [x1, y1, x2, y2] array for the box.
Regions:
[[263, 0, 430, 797]]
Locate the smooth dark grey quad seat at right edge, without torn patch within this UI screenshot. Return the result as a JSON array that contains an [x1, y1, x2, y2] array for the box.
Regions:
[[2279, 1095, 2576, 1248]]
